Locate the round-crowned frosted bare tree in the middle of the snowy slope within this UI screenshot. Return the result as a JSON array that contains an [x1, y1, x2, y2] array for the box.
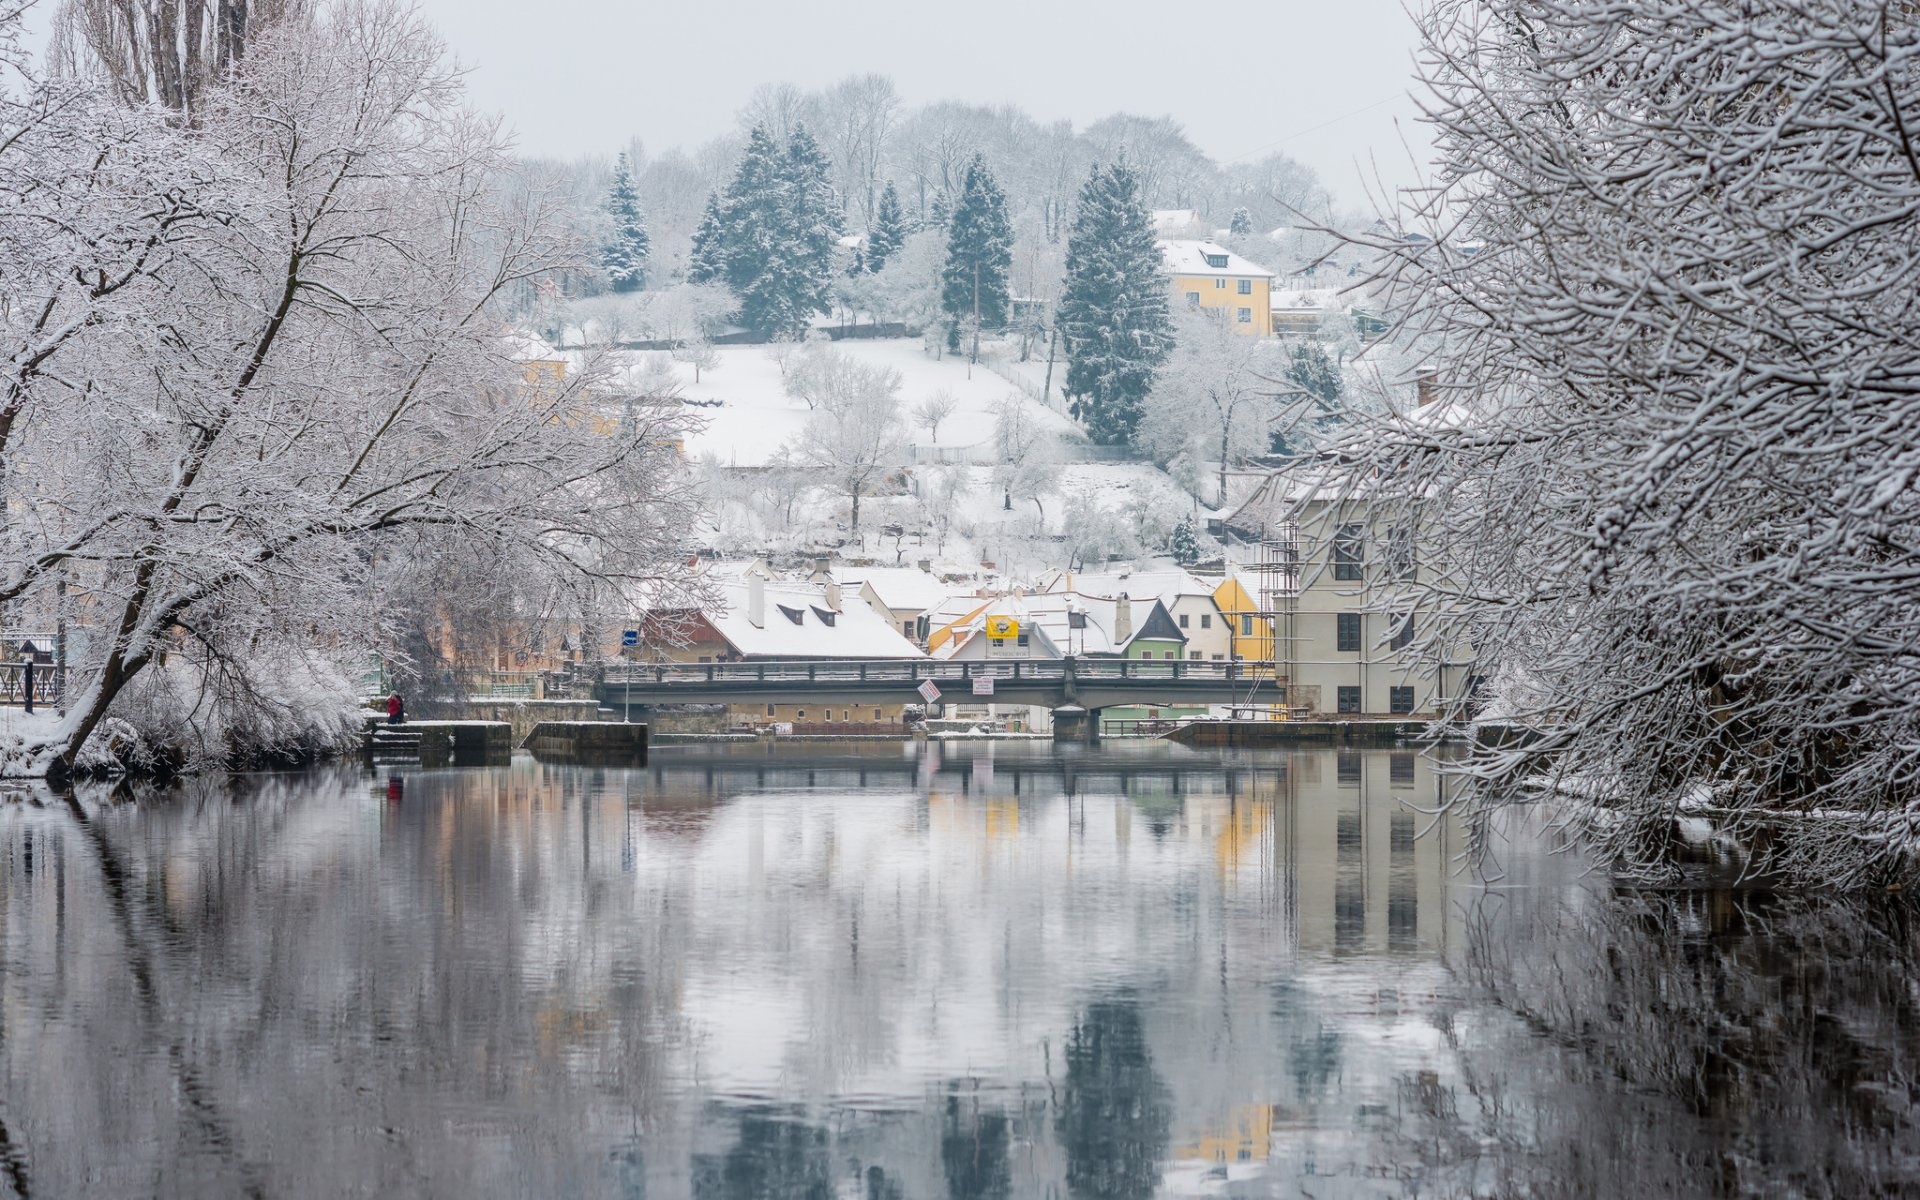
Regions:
[[787, 346, 906, 530]]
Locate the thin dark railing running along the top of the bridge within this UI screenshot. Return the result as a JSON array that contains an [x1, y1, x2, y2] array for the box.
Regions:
[[605, 659, 1279, 687]]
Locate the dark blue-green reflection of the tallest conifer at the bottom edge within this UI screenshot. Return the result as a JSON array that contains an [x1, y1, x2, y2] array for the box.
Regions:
[[1054, 995, 1173, 1200]]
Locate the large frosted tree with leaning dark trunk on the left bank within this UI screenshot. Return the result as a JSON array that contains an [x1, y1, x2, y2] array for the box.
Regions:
[[0, 0, 691, 772]]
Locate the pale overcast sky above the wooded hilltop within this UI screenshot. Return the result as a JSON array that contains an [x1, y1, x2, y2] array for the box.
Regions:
[[22, 0, 1427, 205]]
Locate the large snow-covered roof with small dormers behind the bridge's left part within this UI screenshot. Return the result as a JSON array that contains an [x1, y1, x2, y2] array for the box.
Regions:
[[707, 580, 925, 659]]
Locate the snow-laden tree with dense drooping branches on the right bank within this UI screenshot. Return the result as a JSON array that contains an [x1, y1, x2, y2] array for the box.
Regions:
[[1321, 0, 1920, 887]]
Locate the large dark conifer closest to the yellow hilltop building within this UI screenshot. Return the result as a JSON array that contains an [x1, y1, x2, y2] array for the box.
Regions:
[[1060, 163, 1173, 445]]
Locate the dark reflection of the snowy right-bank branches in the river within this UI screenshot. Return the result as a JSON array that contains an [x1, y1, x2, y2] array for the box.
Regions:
[[1394, 893, 1920, 1196]]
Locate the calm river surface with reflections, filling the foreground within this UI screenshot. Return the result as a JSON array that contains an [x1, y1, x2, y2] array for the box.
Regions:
[[0, 743, 1920, 1200]]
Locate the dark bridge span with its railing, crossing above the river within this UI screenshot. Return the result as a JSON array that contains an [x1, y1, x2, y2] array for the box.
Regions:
[[593, 657, 1286, 710]]
